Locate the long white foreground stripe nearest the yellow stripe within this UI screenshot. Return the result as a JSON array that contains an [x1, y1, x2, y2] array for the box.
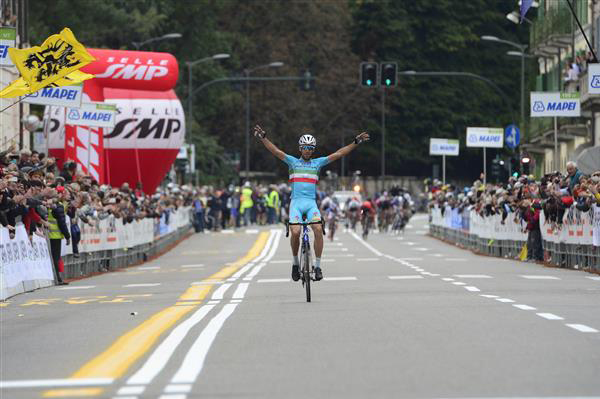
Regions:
[[127, 305, 215, 385]]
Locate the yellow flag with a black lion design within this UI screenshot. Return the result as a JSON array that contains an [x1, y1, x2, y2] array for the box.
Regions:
[[8, 28, 96, 93]]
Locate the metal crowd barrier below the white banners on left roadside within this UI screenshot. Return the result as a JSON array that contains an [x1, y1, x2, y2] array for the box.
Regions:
[[62, 225, 192, 279]]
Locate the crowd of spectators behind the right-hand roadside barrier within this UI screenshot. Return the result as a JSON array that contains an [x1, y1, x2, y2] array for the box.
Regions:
[[428, 162, 600, 261]]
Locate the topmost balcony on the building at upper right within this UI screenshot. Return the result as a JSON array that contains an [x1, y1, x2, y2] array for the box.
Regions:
[[529, 3, 572, 50]]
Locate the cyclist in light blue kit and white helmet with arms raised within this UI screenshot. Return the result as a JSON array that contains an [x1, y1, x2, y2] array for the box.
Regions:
[[254, 125, 369, 281]]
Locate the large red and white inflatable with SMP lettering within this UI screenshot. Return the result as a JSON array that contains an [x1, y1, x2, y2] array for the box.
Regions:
[[45, 49, 185, 193]]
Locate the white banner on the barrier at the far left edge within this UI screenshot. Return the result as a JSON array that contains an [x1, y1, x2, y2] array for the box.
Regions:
[[0, 224, 54, 300]]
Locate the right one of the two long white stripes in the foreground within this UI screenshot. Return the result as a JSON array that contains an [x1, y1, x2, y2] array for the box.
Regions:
[[171, 303, 238, 384]]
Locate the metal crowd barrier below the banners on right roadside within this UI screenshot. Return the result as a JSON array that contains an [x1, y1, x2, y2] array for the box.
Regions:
[[429, 223, 600, 273]]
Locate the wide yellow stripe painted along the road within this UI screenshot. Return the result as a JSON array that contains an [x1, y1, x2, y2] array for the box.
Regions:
[[65, 232, 269, 378]]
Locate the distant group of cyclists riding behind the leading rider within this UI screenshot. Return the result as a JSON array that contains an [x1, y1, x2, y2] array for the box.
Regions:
[[320, 187, 414, 241]]
